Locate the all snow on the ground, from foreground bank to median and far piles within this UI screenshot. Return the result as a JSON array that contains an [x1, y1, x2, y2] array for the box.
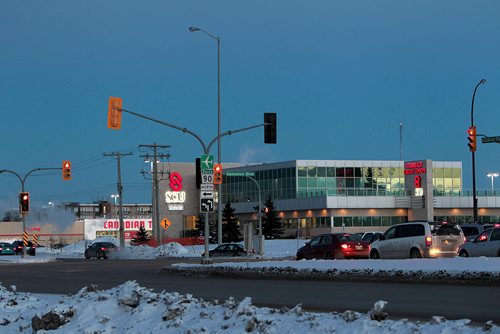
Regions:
[[0, 239, 500, 334]]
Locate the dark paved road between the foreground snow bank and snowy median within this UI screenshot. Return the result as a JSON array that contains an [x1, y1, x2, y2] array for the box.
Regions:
[[0, 259, 500, 323]]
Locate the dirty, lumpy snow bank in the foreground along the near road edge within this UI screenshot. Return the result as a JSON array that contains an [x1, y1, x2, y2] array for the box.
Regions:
[[0, 281, 500, 334]]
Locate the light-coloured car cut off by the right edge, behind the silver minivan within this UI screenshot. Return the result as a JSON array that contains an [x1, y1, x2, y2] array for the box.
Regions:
[[458, 225, 500, 257]]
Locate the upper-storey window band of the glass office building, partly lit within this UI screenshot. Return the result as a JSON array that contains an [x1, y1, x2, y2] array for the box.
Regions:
[[223, 166, 462, 203]]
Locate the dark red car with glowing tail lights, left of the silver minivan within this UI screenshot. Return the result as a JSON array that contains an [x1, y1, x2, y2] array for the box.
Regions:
[[296, 233, 370, 260]]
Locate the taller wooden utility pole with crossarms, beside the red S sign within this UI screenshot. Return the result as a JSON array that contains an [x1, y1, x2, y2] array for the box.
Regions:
[[139, 143, 171, 244]]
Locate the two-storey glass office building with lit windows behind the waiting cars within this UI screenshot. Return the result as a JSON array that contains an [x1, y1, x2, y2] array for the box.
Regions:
[[222, 160, 500, 235]]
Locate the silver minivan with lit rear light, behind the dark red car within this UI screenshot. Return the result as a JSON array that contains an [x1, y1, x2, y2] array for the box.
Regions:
[[370, 221, 465, 259]]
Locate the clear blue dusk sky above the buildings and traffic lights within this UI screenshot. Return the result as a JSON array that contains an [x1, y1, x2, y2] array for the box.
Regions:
[[0, 0, 500, 207]]
